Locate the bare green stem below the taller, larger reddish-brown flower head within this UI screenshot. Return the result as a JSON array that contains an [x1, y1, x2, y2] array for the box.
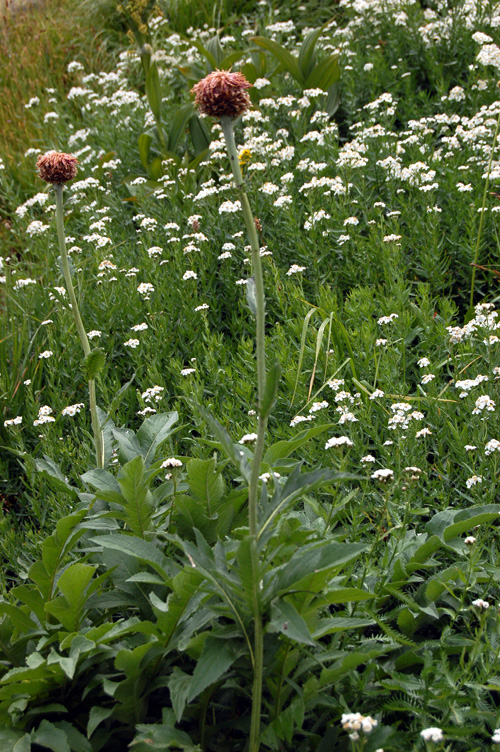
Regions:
[[220, 117, 267, 752]]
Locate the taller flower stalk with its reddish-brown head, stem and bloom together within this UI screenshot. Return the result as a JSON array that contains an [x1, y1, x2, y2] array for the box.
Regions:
[[193, 71, 267, 752]]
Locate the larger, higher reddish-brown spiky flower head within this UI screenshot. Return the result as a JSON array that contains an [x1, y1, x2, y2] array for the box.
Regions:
[[191, 70, 252, 118]]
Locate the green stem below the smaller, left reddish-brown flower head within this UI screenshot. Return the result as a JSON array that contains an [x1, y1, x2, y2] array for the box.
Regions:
[[54, 183, 104, 468]]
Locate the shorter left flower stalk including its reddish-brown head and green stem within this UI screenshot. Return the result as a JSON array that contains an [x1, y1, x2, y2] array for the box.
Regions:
[[37, 153, 104, 468]]
